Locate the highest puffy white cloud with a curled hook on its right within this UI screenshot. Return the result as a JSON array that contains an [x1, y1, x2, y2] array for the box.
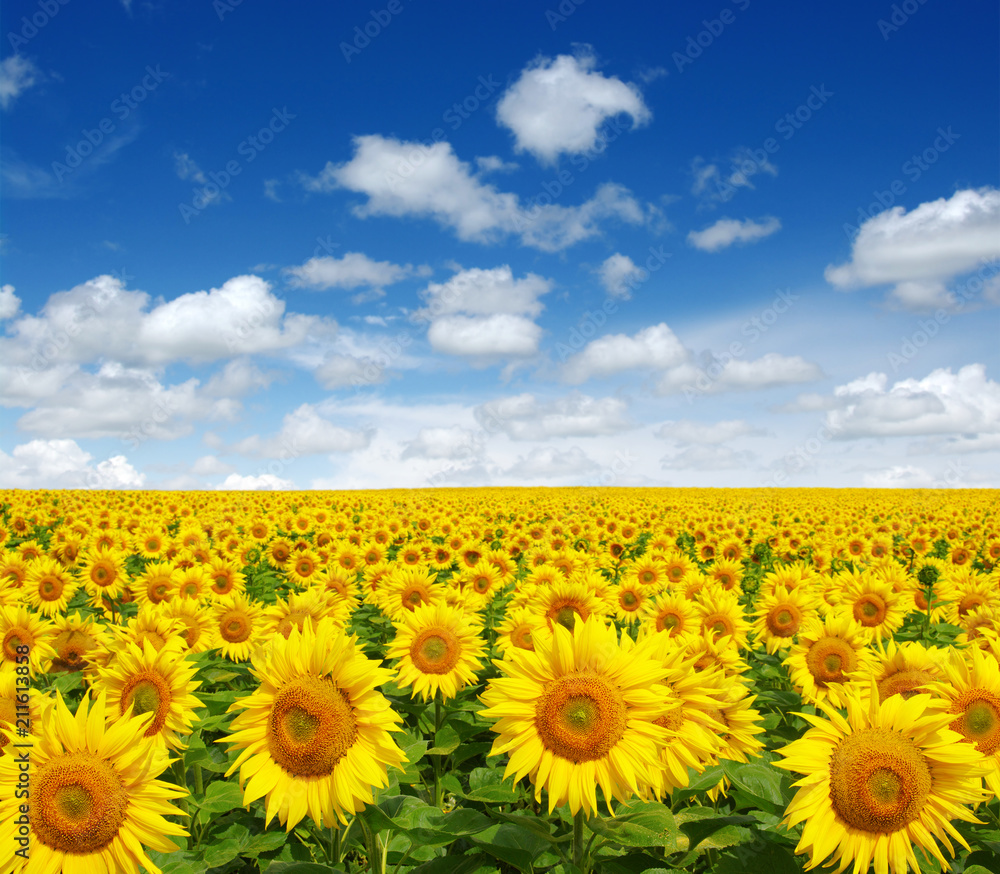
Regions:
[[497, 55, 652, 164]]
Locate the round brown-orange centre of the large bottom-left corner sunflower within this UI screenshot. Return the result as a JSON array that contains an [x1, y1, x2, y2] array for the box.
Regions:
[[29, 751, 128, 855]]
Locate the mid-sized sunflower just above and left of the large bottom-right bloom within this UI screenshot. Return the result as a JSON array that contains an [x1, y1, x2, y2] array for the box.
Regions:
[[783, 613, 873, 705]]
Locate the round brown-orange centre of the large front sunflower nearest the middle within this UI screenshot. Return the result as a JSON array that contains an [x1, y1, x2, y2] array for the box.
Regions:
[[535, 673, 628, 762]]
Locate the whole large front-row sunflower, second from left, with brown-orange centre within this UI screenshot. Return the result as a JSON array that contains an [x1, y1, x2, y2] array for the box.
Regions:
[[220, 621, 406, 831]]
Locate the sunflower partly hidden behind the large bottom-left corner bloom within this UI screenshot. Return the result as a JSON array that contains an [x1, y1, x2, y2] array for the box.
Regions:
[[94, 639, 203, 750]]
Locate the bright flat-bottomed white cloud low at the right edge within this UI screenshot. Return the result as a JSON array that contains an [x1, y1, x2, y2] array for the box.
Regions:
[[826, 364, 1000, 440]]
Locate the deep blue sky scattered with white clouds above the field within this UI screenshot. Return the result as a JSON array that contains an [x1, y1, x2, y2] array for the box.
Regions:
[[0, 0, 1000, 489]]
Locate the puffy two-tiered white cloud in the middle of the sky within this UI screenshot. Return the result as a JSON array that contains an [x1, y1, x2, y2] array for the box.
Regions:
[[413, 264, 552, 366]]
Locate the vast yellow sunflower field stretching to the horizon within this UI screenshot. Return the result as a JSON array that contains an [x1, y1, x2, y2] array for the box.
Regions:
[[0, 488, 1000, 874]]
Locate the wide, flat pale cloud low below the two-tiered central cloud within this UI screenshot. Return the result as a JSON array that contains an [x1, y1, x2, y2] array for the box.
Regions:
[[474, 392, 634, 440]]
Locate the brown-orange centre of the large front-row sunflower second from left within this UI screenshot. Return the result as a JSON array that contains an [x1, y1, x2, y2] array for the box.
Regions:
[[267, 676, 358, 777]]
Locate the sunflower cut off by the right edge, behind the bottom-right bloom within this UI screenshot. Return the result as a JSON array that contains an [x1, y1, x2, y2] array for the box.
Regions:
[[934, 647, 1000, 795]]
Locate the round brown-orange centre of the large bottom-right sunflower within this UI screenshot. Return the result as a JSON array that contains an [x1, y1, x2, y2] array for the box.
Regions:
[[830, 727, 933, 834]]
